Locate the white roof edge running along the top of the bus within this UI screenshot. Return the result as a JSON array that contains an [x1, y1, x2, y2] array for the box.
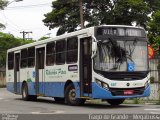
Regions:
[[7, 25, 143, 52]]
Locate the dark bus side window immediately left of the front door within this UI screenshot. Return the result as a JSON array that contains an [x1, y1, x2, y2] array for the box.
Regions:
[[66, 37, 78, 63]]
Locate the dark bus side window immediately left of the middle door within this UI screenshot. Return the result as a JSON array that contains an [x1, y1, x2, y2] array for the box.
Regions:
[[28, 47, 35, 67]]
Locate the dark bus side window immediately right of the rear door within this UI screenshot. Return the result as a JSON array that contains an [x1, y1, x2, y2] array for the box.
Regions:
[[21, 49, 28, 68]]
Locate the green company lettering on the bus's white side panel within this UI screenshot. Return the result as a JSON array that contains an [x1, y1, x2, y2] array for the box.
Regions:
[[46, 69, 66, 75]]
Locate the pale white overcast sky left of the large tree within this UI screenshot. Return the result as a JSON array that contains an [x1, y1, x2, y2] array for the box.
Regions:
[[0, 0, 57, 40]]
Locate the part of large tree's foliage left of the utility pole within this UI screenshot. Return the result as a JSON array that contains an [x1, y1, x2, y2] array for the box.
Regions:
[[43, 0, 80, 35]]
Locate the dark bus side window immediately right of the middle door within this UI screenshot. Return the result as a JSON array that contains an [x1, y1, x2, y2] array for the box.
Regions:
[[46, 42, 55, 66]]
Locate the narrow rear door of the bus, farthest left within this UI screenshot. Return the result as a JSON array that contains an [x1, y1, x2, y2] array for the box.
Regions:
[[14, 53, 20, 93]]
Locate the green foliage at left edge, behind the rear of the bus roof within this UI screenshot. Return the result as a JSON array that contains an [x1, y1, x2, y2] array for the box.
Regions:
[[0, 32, 33, 67]]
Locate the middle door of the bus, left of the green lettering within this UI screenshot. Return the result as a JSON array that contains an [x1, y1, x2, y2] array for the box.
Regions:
[[36, 47, 45, 95]]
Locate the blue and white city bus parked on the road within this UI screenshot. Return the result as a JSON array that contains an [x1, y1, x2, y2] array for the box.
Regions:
[[6, 25, 150, 105]]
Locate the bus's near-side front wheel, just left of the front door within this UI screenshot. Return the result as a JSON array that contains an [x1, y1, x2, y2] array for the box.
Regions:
[[65, 84, 85, 106]]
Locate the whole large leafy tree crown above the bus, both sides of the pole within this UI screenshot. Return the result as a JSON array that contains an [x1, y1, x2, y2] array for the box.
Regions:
[[43, 0, 153, 35]]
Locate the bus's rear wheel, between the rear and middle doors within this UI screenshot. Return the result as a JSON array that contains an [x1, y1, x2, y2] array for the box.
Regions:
[[22, 83, 37, 101]]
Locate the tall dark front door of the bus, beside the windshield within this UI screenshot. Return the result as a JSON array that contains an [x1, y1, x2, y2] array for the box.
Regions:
[[80, 37, 92, 97]]
